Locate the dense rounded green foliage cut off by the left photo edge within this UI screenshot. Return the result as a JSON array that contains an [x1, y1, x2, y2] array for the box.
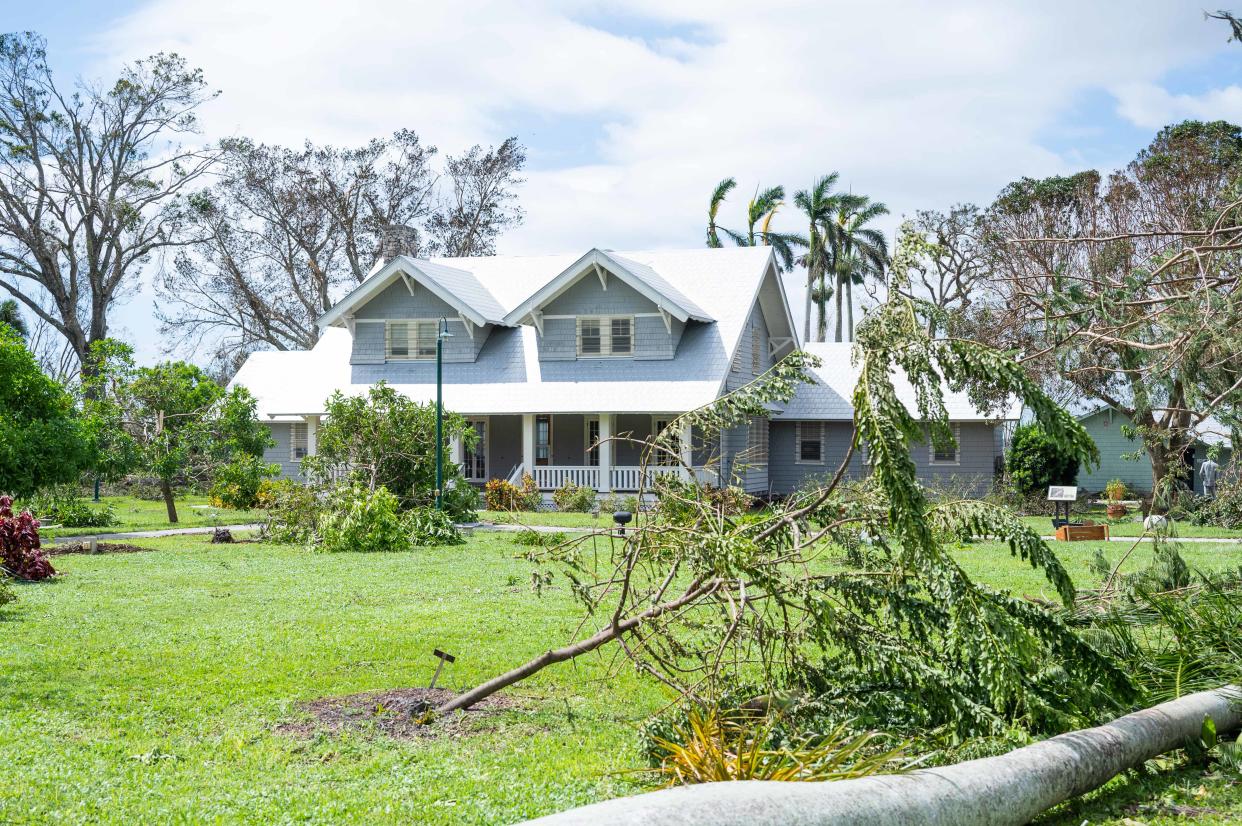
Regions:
[[0, 324, 89, 497]]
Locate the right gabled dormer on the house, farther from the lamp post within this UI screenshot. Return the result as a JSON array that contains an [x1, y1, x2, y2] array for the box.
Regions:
[[504, 250, 714, 360]]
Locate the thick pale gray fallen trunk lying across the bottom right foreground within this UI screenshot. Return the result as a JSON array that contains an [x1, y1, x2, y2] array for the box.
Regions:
[[530, 688, 1242, 826]]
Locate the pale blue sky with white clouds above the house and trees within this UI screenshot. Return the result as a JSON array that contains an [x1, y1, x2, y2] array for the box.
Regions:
[[0, 0, 1242, 356]]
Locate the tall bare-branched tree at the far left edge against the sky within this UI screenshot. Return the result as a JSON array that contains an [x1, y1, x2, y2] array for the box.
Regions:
[[0, 32, 215, 366]]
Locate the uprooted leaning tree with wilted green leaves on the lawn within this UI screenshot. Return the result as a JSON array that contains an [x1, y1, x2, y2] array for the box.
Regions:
[[438, 232, 1134, 735]]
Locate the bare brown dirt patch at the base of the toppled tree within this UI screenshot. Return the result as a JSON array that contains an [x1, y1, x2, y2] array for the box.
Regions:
[[278, 688, 518, 739]]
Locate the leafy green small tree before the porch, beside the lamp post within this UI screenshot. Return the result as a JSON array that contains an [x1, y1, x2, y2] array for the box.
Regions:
[[304, 381, 478, 519]]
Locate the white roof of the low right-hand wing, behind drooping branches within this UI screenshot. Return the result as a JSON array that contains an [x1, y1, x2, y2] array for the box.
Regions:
[[774, 342, 1018, 421]]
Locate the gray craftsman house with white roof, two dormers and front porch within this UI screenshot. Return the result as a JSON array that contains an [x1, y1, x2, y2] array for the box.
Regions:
[[233, 247, 1000, 496]]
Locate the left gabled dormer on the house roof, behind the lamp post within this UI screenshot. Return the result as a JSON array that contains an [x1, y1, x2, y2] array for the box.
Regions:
[[319, 256, 504, 364]]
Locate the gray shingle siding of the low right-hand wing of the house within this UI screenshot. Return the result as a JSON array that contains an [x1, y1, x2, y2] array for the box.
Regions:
[[769, 420, 1000, 496]]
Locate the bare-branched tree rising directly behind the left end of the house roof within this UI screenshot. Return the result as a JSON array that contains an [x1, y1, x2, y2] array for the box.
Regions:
[[159, 130, 524, 360]]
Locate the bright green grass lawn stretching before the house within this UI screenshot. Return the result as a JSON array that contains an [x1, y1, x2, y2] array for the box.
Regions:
[[0, 533, 1242, 824]]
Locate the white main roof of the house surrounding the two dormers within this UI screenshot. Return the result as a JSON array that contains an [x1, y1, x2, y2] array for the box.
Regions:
[[231, 247, 796, 419]]
